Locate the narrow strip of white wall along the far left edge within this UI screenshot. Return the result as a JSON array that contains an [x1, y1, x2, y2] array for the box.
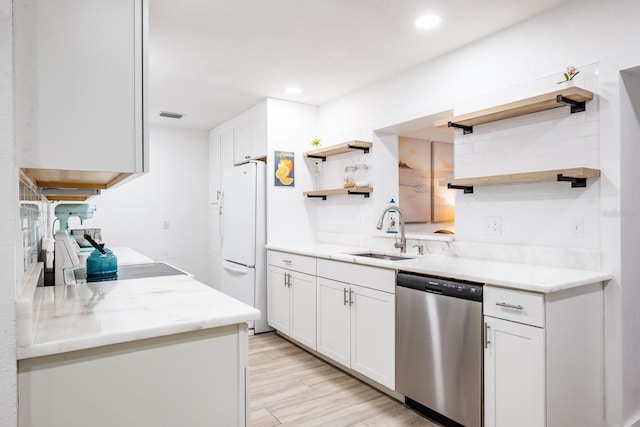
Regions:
[[0, 0, 17, 427]]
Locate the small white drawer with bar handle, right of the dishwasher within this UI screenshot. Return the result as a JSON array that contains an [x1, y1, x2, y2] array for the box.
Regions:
[[483, 286, 545, 328]]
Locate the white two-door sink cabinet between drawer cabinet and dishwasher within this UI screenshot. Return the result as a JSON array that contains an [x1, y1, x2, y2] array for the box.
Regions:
[[317, 259, 395, 389]]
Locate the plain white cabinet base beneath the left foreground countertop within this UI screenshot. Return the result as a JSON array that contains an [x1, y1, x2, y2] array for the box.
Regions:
[[18, 323, 250, 427]]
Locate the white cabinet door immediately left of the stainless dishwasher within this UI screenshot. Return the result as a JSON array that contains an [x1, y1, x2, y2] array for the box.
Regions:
[[350, 285, 395, 389]]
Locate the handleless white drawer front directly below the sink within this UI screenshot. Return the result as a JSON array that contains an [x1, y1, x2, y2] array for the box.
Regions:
[[318, 258, 396, 294]]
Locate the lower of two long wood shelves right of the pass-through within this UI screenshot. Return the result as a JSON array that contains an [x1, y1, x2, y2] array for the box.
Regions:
[[445, 168, 600, 193]]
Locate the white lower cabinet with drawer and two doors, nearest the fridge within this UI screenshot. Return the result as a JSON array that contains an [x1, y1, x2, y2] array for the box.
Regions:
[[267, 251, 316, 350]]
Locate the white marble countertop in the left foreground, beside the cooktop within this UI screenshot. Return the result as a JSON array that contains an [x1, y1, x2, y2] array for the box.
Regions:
[[17, 249, 260, 360]]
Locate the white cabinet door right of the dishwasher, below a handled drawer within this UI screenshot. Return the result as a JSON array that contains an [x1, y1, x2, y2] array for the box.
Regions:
[[484, 316, 546, 427]]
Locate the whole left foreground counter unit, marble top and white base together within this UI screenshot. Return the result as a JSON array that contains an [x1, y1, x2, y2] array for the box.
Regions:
[[17, 251, 260, 427]]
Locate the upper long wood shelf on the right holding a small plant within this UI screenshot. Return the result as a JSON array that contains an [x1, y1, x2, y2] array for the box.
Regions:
[[435, 86, 593, 134]]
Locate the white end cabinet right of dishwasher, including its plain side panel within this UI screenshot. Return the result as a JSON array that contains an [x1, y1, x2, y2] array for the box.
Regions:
[[483, 283, 604, 427]]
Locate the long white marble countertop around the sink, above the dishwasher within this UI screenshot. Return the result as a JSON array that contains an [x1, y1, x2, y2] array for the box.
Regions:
[[267, 244, 613, 293]]
